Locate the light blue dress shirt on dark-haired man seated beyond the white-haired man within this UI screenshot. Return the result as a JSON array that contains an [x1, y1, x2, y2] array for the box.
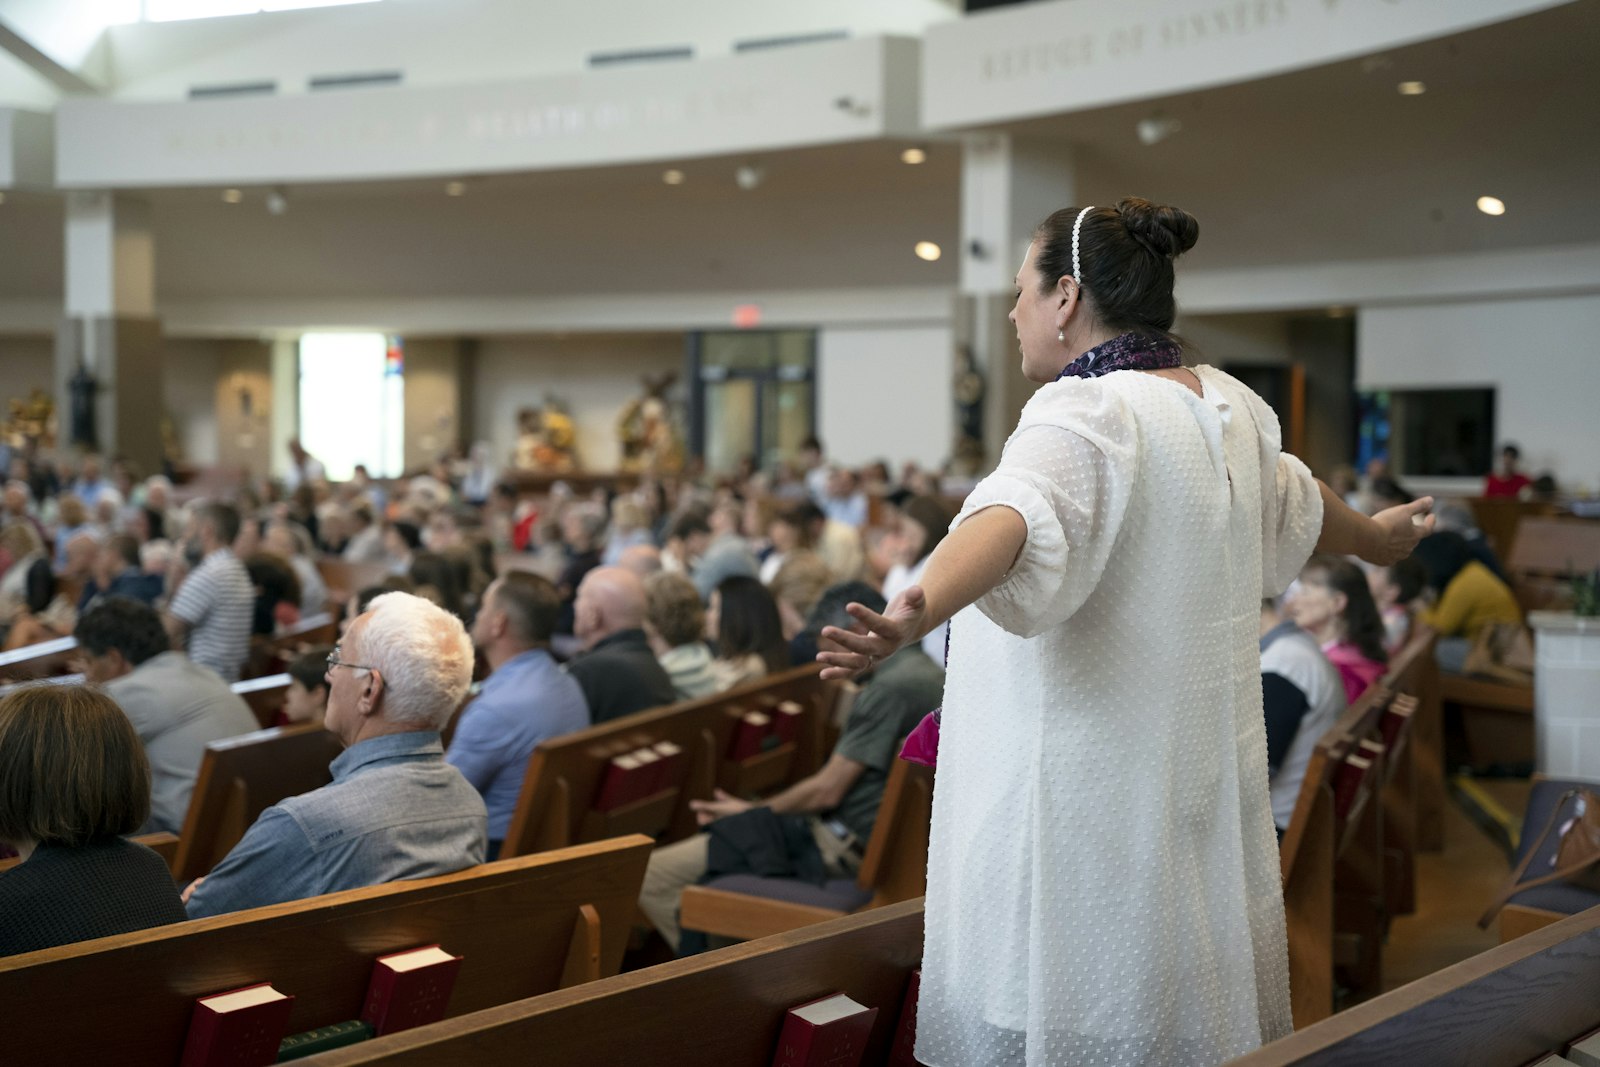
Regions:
[[445, 648, 589, 841]]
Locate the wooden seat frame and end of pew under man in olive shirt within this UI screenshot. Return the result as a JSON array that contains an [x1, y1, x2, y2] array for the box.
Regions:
[[678, 760, 933, 941]]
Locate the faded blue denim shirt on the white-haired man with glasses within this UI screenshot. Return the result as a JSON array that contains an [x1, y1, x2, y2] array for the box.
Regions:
[[189, 729, 486, 918]]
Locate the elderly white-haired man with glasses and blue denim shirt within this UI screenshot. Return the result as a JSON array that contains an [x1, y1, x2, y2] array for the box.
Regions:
[[184, 593, 488, 918]]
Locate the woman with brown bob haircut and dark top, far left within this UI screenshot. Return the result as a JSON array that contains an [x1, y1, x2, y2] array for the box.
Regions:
[[0, 683, 186, 957]]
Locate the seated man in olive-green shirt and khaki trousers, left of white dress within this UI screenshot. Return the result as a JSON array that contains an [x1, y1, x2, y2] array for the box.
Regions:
[[638, 582, 944, 949]]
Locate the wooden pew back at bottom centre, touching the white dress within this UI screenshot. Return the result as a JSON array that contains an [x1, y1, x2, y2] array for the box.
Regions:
[[306, 899, 922, 1067]]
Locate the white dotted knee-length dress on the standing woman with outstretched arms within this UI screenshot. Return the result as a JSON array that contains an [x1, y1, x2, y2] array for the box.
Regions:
[[917, 366, 1322, 1067]]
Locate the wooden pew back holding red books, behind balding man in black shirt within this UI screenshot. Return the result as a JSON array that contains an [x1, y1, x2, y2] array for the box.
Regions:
[[501, 664, 834, 856]]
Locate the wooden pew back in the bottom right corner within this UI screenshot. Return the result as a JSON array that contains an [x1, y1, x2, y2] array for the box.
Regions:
[[1222, 907, 1600, 1067]]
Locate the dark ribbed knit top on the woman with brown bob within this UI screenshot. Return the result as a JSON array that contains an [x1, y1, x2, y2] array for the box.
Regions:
[[0, 837, 187, 957]]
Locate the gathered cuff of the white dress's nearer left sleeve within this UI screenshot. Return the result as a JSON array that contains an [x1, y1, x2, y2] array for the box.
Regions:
[[950, 470, 1067, 637]]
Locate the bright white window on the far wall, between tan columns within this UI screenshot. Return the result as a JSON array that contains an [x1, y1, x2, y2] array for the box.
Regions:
[[299, 333, 405, 482]]
